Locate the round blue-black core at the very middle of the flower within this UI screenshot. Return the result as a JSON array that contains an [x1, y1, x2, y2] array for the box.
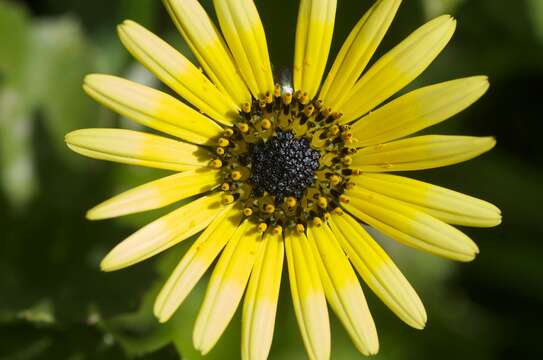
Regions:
[[249, 131, 320, 202]]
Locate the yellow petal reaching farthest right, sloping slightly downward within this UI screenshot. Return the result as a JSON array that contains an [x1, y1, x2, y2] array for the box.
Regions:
[[351, 173, 501, 227]]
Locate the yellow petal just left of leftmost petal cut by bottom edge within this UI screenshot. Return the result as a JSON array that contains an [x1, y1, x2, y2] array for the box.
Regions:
[[192, 221, 262, 355]]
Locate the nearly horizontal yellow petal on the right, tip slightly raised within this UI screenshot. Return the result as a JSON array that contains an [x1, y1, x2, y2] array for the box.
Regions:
[[352, 135, 496, 172]]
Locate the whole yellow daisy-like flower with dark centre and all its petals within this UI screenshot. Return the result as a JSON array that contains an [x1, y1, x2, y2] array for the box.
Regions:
[[66, 0, 501, 359]]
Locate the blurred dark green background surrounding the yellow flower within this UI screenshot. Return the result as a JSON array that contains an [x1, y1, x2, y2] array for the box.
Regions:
[[0, 0, 543, 360]]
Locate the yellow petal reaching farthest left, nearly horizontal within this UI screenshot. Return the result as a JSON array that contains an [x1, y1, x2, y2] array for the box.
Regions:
[[65, 129, 211, 171]]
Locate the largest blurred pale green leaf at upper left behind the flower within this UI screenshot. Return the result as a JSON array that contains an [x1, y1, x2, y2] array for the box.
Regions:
[[28, 17, 99, 161]]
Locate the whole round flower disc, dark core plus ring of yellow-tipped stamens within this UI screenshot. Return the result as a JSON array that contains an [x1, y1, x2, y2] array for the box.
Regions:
[[210, 84, 360, 234]]
